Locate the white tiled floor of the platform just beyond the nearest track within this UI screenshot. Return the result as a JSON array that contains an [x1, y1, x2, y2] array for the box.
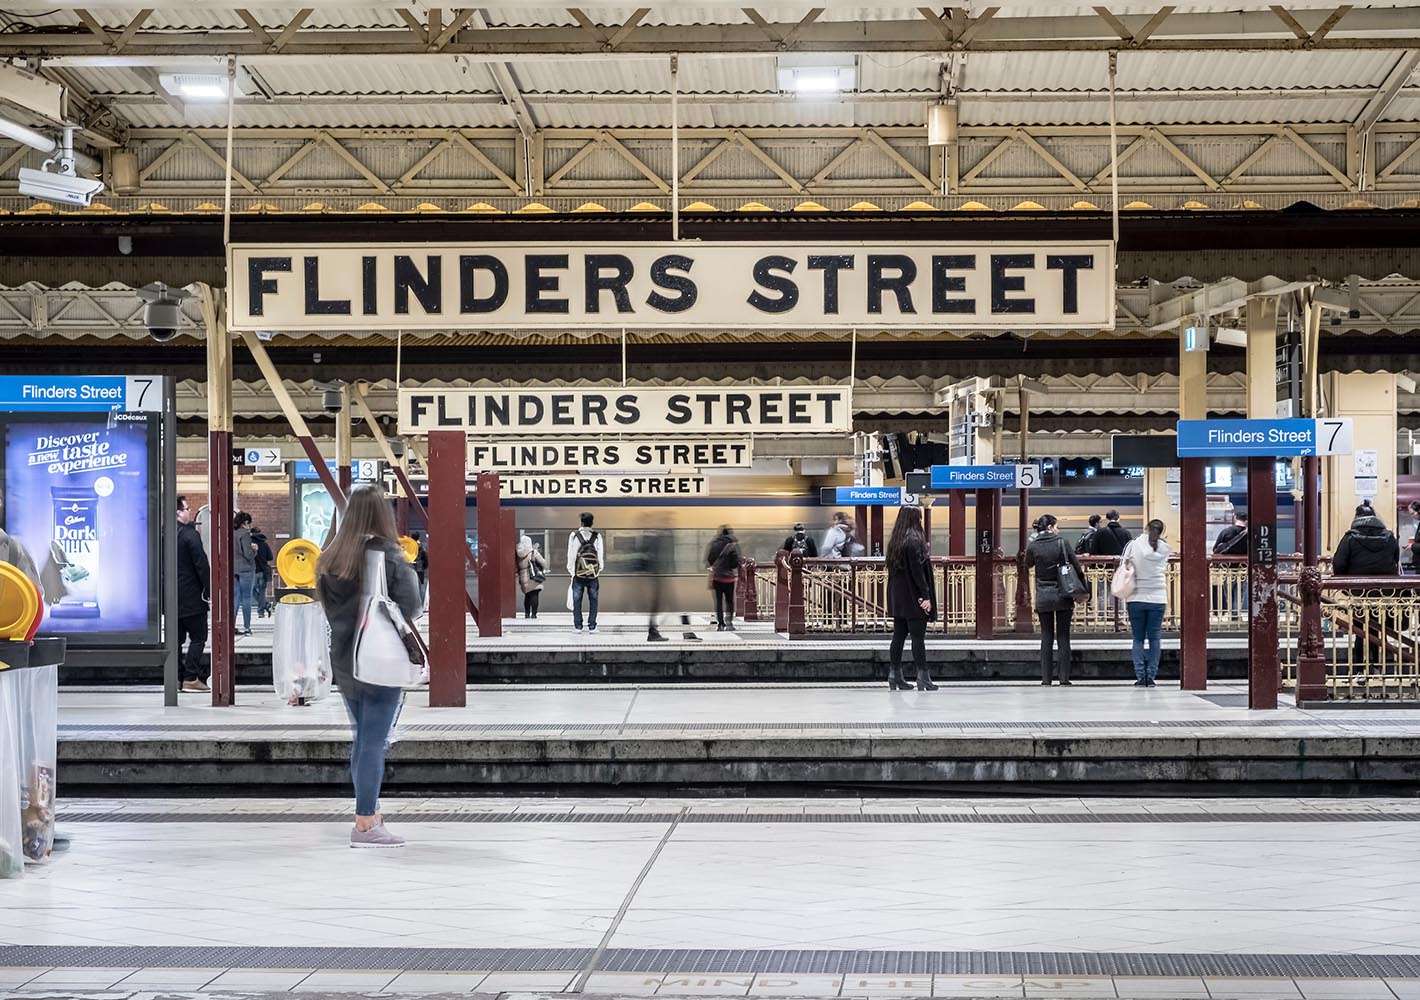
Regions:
[[60, 680, 1420, 740]]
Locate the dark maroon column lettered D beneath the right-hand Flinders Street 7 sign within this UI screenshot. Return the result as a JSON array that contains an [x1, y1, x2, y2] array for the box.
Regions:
[[1247, 456, 1281, 709]]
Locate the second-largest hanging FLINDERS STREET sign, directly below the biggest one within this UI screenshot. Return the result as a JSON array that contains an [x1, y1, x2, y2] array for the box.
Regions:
[[399, 385, 853, 436]]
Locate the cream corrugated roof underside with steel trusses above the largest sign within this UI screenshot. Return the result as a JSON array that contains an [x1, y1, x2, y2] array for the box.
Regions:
[[0, 0, 1420, 214]]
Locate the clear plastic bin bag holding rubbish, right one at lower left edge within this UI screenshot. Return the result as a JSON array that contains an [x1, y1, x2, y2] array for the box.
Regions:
[[16, 666, 60, 862]]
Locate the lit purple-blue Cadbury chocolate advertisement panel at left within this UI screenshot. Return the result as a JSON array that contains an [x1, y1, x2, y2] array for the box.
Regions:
[[0, 403, 160, 646]]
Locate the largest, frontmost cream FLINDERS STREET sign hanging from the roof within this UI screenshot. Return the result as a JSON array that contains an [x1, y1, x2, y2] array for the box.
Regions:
[[227, 240, 1115, 331]]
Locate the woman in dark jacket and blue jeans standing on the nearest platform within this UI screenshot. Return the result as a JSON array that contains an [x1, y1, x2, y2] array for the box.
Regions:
[[315, 484, 422, 848]]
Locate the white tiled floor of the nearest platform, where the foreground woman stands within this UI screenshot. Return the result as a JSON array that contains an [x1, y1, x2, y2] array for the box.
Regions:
[[0, 798, 1420, 1000]]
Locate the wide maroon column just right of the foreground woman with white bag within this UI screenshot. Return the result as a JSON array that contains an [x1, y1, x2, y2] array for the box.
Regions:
[[429, 430, 465, 707]]
